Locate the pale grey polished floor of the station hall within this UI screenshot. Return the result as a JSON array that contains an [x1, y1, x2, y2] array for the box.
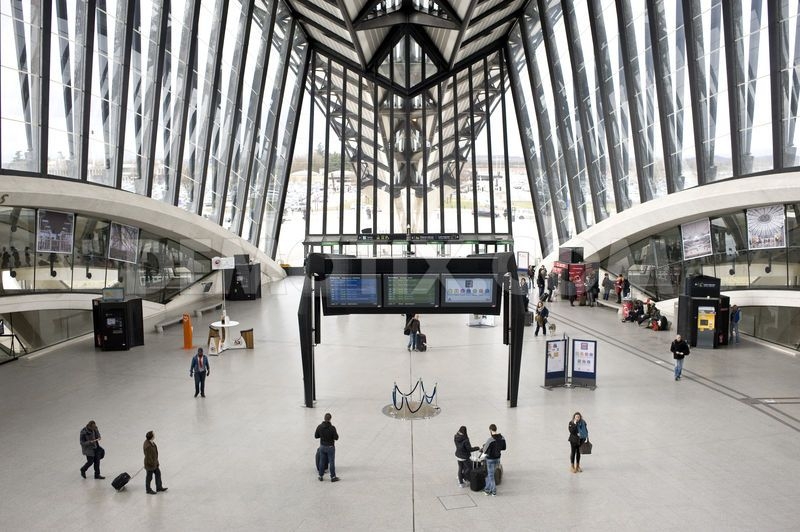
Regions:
[[0, 278, 800, 531]]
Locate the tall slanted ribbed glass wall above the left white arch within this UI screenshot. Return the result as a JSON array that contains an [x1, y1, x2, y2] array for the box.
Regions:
[[0, 0, 307, 255]]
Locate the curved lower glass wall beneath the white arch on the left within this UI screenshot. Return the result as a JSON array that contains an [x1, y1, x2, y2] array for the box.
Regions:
[[0, 207, 211, 303]]
